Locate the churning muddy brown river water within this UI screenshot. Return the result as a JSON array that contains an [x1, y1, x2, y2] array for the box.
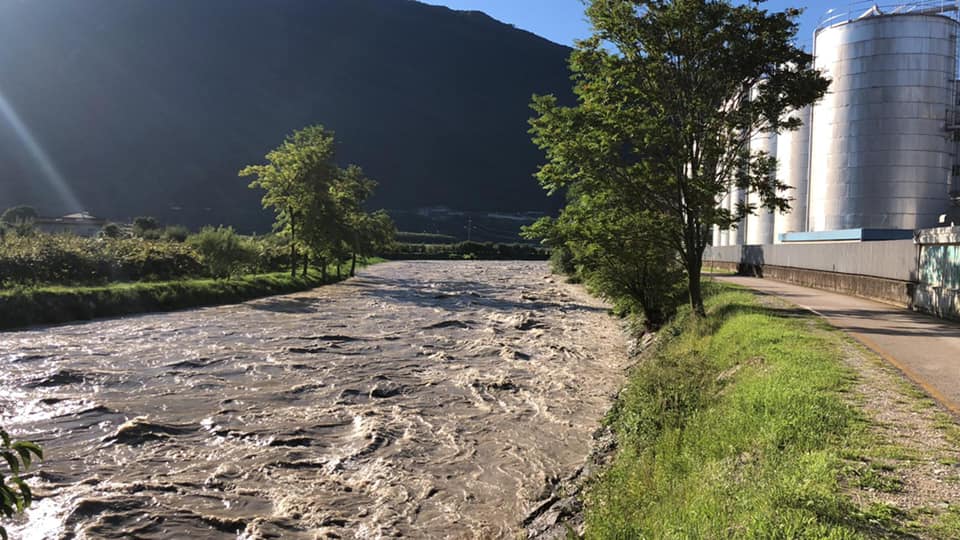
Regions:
[[0, 262, 626, 538]]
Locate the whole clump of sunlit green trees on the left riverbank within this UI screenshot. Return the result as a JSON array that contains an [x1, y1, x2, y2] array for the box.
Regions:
[[240, 126, 396, 276]]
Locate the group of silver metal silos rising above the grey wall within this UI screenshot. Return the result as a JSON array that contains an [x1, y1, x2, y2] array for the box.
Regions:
[[713, 2, 960, 246]]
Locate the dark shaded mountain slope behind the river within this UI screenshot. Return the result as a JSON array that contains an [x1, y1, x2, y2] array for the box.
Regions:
[[0, 0, 571, 230]]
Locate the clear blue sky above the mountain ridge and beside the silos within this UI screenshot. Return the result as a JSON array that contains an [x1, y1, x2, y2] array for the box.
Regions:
[[421, 0, 832, 49]]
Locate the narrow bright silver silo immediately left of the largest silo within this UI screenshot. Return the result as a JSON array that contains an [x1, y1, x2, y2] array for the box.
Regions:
[[773, 107, 811, 243]]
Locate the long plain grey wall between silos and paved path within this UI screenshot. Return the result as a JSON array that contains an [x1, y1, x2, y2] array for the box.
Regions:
[[703, 240, 918, 282]]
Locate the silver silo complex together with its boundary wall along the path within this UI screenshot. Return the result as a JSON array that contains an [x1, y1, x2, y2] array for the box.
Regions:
[[704, 1, 960, 318]]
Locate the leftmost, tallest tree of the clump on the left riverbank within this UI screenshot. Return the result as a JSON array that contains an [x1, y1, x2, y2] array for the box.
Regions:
[[240, 126, 339, 276]]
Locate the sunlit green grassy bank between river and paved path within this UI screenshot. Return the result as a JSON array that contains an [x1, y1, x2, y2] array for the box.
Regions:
[[586, 288, 960, 539]]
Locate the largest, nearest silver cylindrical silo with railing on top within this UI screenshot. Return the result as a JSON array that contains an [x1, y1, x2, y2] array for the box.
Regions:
[[808, 9, 958, 231]]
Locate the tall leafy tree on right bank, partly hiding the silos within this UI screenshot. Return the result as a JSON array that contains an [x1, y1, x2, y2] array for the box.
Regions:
[[531, 0, 828, 316]]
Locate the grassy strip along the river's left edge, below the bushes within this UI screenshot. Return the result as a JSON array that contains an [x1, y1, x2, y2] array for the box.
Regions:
[[0, 259, 381, 330]]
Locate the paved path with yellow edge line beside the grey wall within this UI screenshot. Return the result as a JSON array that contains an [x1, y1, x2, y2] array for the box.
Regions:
[[717, 276, 960, 414]]
